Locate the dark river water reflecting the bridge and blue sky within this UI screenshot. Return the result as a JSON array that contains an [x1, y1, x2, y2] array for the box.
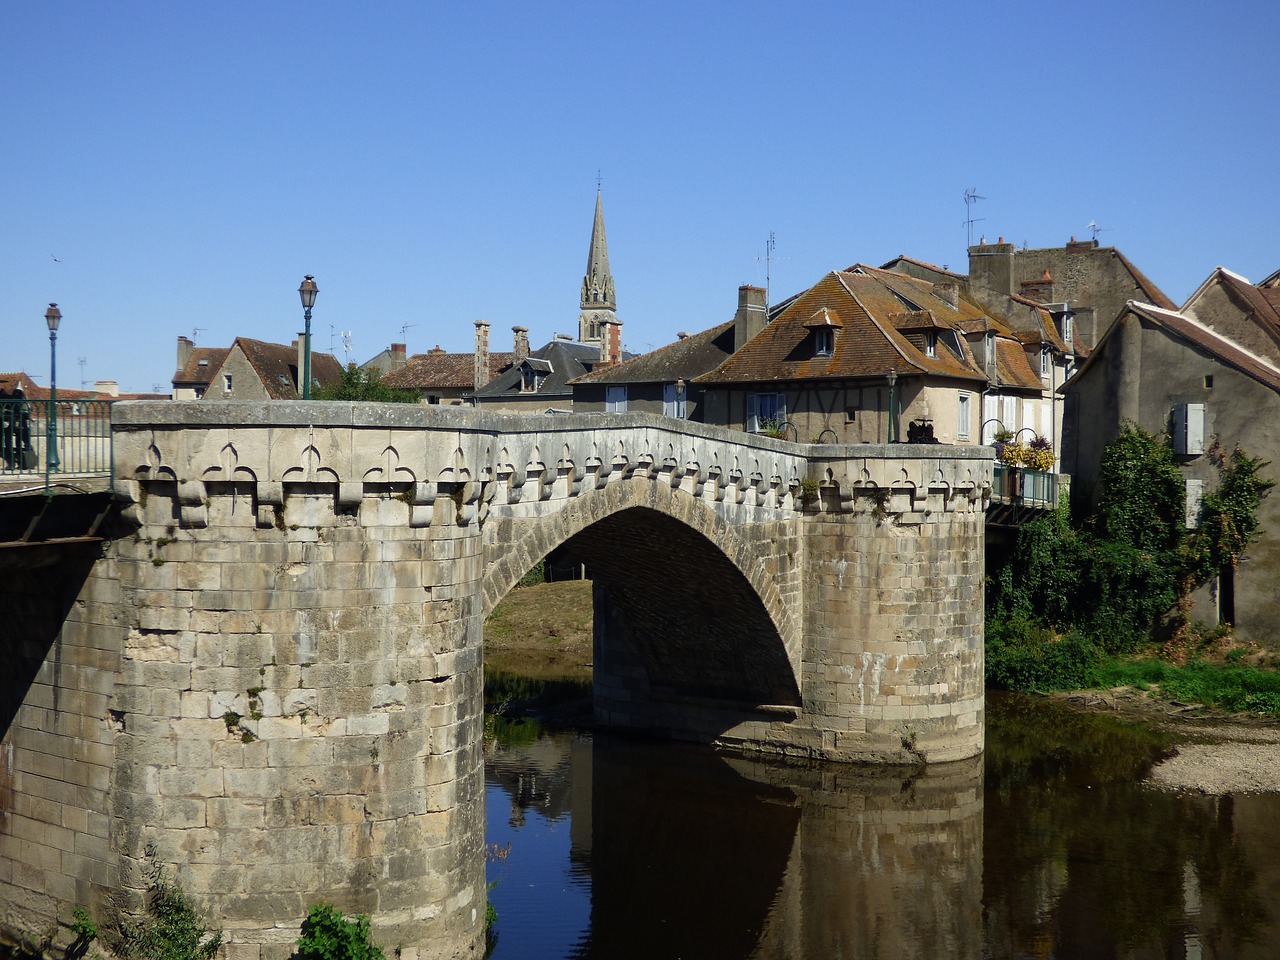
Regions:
[[486, 695, 1280, 960]]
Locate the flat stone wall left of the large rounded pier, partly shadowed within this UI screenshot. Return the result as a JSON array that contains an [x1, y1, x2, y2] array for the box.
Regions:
[[0, 544, 123, 947]]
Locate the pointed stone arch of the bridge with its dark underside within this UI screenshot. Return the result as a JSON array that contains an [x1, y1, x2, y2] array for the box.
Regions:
[[484, 479, 803, 709]]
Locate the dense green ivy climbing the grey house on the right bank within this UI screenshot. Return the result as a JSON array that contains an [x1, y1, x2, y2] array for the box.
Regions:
[[987, 424, 1275, 686]]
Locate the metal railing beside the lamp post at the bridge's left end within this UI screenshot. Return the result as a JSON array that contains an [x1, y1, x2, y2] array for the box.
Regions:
[[0, 398, 113, 490]]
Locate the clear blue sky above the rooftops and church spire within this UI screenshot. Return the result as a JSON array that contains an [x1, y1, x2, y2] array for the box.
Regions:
[[0, 0, 1280, 390]]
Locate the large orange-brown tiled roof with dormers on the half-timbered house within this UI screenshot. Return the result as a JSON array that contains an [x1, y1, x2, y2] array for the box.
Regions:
[[698, 265, 998, 383]]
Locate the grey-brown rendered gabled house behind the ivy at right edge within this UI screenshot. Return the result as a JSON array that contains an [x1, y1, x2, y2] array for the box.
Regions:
[[1062, 270, 1280, 640]]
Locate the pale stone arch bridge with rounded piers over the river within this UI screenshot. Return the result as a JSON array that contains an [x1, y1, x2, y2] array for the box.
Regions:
[[0, 402, 991, 960]]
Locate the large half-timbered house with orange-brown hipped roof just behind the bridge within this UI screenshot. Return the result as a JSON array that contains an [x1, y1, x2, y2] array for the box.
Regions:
[[694, 264, 1044, 444]]
